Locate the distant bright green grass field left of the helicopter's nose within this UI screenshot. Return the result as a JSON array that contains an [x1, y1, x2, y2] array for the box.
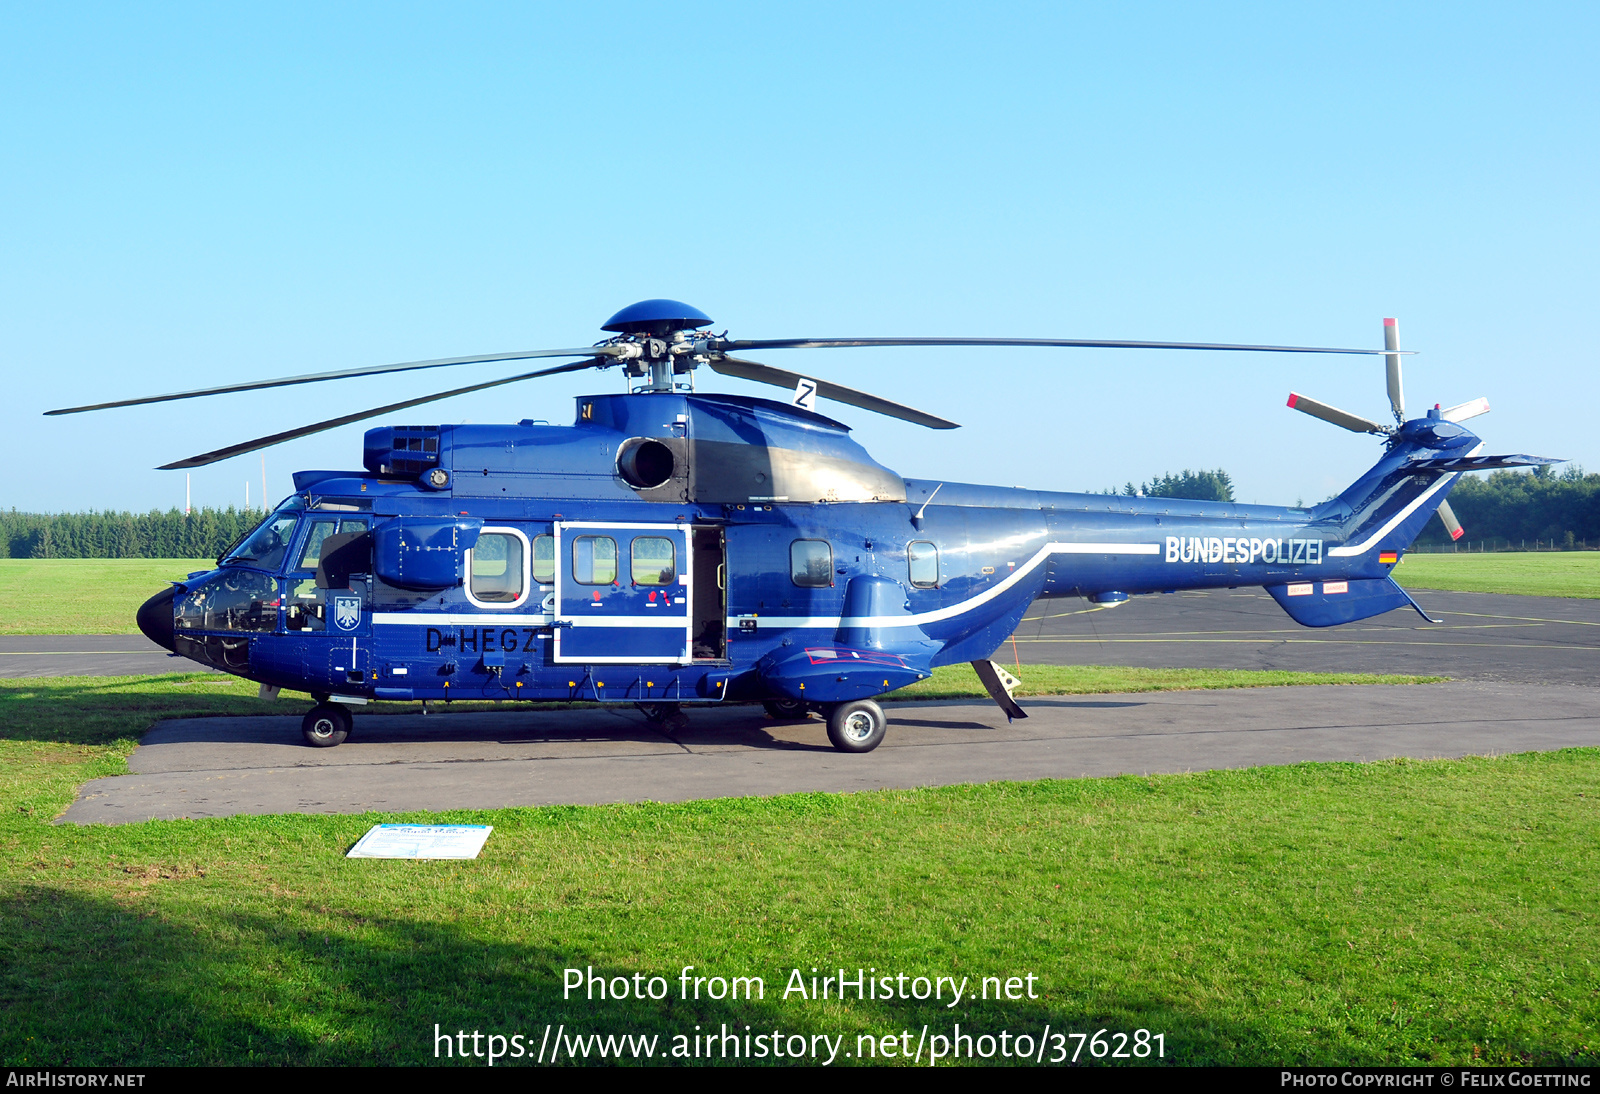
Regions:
[[0, 558, 216, 635]]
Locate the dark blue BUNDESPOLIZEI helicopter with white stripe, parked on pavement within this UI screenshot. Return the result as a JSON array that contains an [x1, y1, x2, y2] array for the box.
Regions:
[[48, 299, 1558, 753]]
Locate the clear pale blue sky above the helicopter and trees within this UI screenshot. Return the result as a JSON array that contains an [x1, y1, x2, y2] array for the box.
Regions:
[[0, 3, 1600, 512]]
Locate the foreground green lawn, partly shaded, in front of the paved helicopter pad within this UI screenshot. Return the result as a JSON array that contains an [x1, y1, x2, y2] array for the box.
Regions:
[[0, 670, 1600, 1065]]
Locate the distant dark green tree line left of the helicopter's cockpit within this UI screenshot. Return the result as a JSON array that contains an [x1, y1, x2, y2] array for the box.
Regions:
[[0, 505, 261, 558]]
